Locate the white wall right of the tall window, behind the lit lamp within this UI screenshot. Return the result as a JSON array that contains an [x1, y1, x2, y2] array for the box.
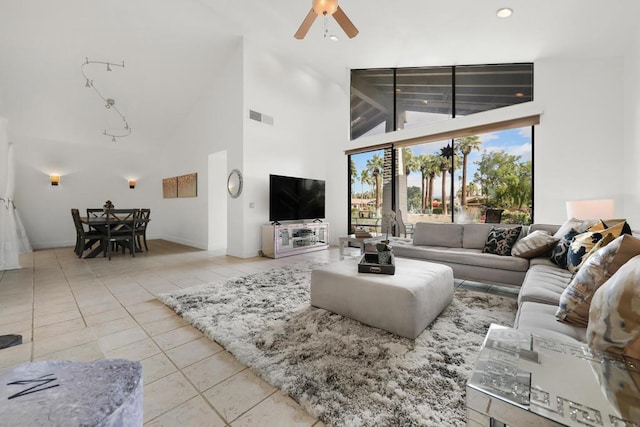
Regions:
[[534, 57, 624, 226]]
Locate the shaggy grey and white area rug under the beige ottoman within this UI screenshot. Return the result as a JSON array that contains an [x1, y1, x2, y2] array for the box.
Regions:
[[159, 262, 516, 426]]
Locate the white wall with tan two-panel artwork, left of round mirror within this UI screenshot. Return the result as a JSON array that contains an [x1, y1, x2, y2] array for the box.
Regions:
[[154, 39, 243, 253]]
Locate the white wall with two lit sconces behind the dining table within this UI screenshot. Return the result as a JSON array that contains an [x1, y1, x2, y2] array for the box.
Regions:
[[15, 135, 161, 249]]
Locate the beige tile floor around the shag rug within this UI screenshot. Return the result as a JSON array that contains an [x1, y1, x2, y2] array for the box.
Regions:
[[0, 240, 517, 426]]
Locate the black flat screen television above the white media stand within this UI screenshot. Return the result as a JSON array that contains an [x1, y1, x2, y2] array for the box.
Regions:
[[269, 175, 325, 222]]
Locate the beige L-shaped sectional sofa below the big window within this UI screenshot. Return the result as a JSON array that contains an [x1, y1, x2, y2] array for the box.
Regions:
[[390, 223, 636, 343]]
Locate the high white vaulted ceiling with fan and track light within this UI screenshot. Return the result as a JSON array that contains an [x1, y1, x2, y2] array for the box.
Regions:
[[0, 0, 640, 147]]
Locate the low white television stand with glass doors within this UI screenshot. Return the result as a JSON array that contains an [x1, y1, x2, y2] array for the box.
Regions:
[[262, 222, 329, 258]]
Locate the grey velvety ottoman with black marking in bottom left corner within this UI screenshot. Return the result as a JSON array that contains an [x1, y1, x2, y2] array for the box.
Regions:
[[0, 359, 143, 427]]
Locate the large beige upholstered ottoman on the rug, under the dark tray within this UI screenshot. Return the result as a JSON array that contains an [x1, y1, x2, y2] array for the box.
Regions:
[[311, 258, 453, 339]]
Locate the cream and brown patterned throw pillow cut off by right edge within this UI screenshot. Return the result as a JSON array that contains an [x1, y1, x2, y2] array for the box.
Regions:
[[587, 255, 640, 359]]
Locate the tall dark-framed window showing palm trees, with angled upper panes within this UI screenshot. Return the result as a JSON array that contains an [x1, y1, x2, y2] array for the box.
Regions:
[[349, 64, 533, 231]]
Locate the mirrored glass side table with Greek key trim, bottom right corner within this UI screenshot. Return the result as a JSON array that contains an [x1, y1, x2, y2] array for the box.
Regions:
[[467, 325, 640, 427]]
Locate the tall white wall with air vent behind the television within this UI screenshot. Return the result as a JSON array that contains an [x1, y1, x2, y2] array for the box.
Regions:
[[239, 42, 349, 257]]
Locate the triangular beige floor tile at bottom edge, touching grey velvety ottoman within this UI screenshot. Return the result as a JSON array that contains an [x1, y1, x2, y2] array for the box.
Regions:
[[145, 396, 226, 427]]
